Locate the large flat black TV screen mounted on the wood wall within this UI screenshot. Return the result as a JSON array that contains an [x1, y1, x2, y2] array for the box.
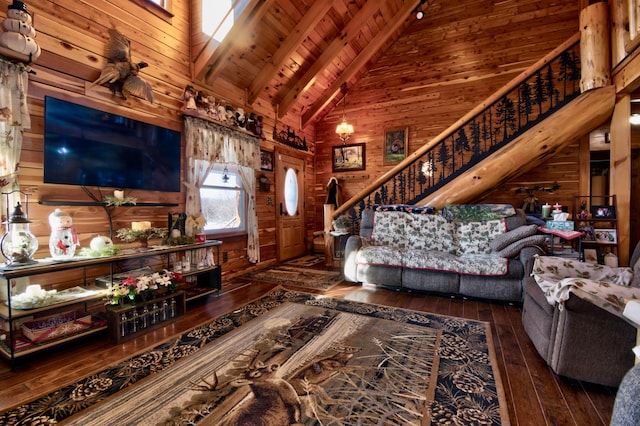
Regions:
[[44, 96, 181, 192]]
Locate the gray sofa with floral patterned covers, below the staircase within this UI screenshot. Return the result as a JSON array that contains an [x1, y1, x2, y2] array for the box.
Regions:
[[344, 204, 545, 303]]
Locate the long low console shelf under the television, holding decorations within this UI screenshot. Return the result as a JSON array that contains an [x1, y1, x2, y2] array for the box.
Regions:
[[0, 240, 222, 368]]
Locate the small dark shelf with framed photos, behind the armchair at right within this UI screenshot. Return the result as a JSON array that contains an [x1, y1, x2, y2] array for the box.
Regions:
[[573, 195, 619, 266]]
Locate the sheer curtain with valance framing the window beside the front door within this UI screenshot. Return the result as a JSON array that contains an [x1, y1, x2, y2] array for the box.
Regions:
[[185, 117, 260, 263]]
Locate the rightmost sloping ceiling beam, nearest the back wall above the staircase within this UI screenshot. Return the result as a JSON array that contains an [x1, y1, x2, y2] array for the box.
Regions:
[[302, 0, 421, 128]]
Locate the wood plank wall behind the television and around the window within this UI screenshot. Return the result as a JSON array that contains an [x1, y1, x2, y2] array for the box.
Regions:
[[9, 0, 314, 284]]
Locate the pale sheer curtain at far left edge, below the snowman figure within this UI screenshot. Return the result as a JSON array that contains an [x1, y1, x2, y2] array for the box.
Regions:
[[0, 59, 31, 225]]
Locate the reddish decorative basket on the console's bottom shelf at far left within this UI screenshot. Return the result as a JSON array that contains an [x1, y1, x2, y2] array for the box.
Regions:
[[22, 311, 91, 343]]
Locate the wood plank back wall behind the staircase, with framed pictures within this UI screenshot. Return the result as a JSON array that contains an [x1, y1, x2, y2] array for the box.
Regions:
[[315, 0, 580, 229]]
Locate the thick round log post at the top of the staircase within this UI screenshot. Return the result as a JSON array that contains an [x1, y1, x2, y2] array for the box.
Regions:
[[580, 2, 611, 92]]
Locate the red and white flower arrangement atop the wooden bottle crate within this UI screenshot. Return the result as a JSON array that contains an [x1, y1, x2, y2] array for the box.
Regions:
[[107, 269, 182, 305]]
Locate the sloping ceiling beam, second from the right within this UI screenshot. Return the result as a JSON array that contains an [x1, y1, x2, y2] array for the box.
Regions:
[[278, 1, 380, 118]]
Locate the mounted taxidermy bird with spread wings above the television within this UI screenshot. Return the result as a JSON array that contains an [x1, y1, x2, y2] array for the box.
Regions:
[[89, 28, 153, 103]]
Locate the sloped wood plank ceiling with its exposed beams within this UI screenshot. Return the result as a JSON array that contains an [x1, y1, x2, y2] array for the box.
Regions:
[[191, 0, 432, 127]]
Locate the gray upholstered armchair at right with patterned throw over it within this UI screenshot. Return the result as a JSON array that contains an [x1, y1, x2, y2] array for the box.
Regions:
[[522, 244, 640, 386]]
